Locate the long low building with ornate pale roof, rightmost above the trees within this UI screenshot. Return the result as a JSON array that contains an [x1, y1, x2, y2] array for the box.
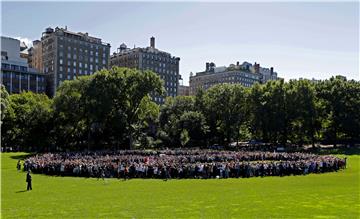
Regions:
[[190, 62, 277, 95]]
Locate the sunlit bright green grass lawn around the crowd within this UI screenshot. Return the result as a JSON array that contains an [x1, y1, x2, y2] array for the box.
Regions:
[[1, 153, 360, 219]]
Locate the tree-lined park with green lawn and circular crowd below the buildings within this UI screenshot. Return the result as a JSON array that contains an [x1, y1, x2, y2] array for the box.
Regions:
[[1, 68, 360, 218]]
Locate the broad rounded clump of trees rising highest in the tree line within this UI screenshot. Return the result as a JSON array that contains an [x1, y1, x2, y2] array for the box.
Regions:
[[54, 67, 164, 149]]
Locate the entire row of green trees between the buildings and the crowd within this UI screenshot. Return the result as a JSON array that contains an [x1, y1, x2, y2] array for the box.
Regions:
[[1, 67, 360, 151]]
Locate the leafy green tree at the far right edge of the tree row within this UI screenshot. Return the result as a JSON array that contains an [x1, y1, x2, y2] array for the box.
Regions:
[[316, 77, 360, 146]]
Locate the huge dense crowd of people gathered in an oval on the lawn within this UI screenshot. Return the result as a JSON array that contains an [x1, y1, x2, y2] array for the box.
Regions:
[[24, 149, 346, 179]]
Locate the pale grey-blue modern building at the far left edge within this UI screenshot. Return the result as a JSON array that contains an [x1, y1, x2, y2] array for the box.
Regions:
[[1, 36, 45, 94]]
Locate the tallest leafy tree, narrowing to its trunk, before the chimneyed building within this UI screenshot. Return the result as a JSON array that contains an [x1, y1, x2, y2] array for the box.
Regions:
[[95, 67, 165, 148]]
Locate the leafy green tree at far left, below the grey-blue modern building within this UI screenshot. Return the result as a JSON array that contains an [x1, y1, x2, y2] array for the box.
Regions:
[[2, 92, 52, 151]]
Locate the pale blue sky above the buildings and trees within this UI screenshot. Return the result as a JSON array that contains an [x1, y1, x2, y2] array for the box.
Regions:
[[1, 2, 360, 84]]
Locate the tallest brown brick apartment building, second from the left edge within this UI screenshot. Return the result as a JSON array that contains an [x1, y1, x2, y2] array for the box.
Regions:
[[29, 27, 110, 96]]
